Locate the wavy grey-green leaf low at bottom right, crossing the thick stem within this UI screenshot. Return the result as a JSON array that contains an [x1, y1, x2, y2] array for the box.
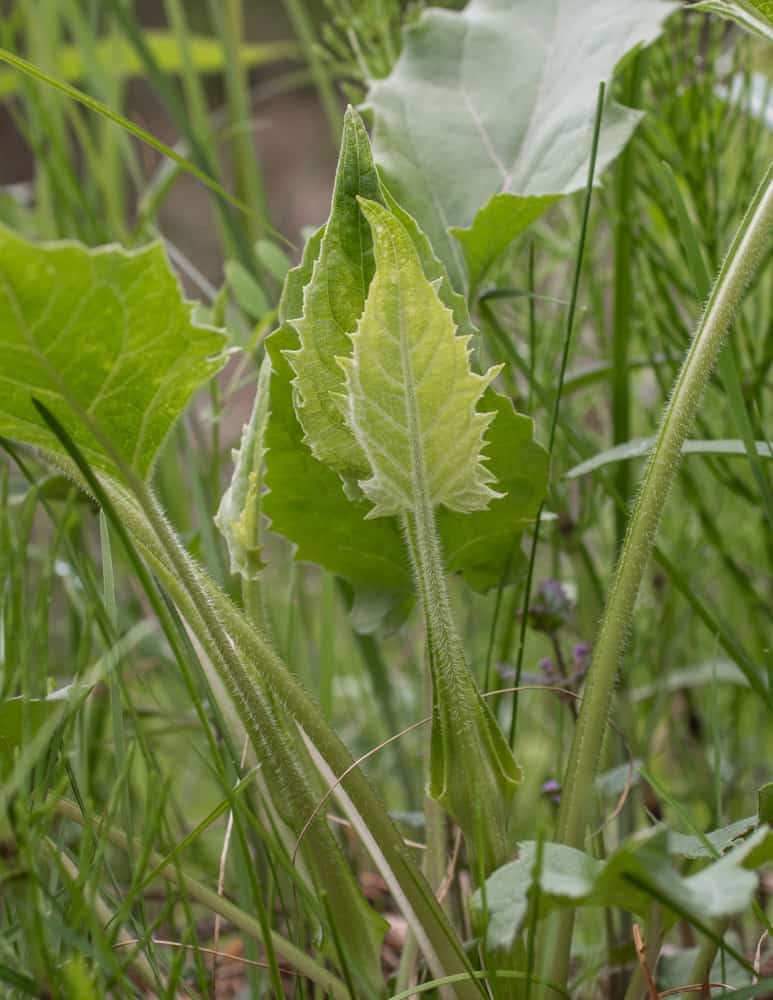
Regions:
[[471, 826, 773, 952]]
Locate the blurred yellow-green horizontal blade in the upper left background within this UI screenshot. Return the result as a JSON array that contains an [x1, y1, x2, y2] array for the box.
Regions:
[[0, 29, 299, 98]]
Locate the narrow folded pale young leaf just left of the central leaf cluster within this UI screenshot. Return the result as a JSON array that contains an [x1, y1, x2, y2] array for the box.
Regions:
[[215, 355, 271, 580]]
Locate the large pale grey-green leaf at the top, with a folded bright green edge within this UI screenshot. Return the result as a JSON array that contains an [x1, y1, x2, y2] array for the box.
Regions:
[[367, 0, 675, 288]]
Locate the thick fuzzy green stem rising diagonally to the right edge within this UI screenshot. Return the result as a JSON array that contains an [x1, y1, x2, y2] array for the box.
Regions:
[[550, 165, 773, 984]]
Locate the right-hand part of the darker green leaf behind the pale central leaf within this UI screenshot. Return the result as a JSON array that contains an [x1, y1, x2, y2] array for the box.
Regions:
[[437, 389, 548, 591]]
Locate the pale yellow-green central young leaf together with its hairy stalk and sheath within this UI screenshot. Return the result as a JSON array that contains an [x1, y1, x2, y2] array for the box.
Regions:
[[339, 199, 521, 872]]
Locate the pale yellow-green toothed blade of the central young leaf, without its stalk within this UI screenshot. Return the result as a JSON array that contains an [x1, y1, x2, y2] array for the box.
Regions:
[[340, 199, 500, 517]]
